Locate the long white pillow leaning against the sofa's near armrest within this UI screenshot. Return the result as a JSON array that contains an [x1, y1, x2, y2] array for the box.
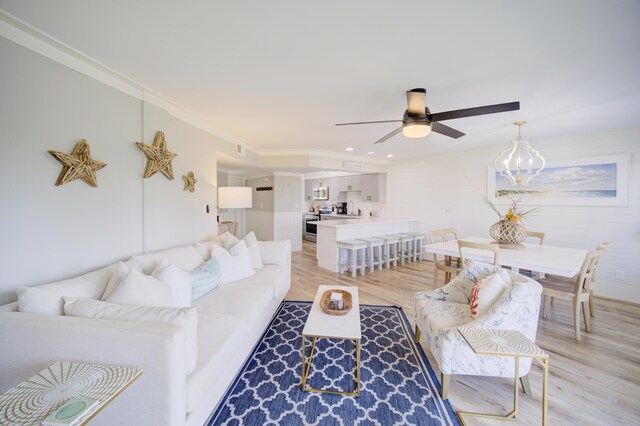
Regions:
[[64, 297, 198, 374]]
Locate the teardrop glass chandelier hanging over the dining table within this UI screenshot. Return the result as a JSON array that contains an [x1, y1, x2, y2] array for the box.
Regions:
[[493, 121, 545, 186]]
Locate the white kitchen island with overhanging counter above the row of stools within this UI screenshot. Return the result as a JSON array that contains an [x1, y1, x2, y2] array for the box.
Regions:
[[315, 217, 418, 272]]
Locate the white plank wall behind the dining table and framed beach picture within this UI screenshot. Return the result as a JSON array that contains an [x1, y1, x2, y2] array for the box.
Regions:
[[387, 129, 640, 303]]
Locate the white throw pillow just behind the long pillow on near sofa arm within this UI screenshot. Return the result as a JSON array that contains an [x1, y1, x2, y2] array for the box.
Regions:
[[106, 268, 173, 306]]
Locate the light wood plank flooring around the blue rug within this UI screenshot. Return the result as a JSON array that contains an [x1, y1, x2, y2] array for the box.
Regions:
[[286, 241, 640, 425]]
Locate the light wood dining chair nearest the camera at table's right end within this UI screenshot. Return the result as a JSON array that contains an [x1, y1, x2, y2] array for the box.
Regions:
[[538, 243, 609, 342]]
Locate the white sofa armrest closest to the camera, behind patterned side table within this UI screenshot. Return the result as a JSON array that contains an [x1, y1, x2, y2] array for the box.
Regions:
[[0, 312, 186, 425]]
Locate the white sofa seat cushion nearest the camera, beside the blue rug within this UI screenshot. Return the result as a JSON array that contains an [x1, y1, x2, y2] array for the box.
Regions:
[[187, 312, 248, 413]]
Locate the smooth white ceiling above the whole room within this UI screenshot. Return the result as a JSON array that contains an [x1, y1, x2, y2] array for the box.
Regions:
[[0, 0, 640, 168]]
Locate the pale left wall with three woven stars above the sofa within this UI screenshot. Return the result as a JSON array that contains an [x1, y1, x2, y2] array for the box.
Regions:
[[0, 37, 229, 304]]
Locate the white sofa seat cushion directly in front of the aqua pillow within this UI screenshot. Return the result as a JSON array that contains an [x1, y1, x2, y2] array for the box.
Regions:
[[193, 283, 273, 325]]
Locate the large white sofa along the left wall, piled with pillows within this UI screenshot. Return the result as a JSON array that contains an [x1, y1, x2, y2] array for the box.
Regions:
[[0, 241, 291, 426]]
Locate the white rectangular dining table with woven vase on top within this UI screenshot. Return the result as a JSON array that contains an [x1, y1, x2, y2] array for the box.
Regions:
[[423, 237, 587, 278]]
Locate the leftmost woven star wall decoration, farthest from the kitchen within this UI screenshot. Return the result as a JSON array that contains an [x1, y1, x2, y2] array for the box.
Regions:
[[49, 139, 107, 188]]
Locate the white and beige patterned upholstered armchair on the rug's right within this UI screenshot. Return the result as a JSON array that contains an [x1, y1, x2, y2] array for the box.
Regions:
[[415, 261, 542, 398]]
